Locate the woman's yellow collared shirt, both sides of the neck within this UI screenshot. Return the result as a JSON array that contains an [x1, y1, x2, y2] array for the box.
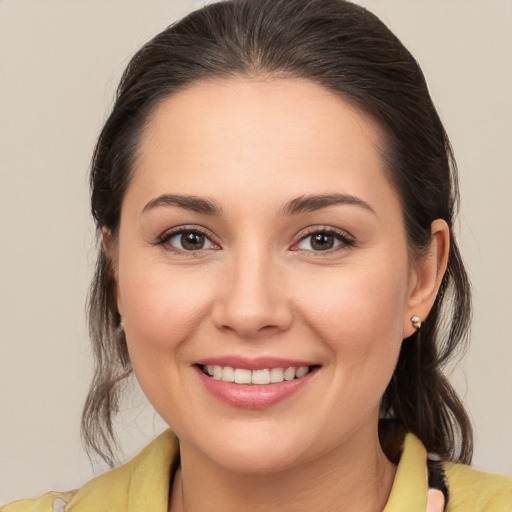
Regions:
[[4, 430, 512, 512]]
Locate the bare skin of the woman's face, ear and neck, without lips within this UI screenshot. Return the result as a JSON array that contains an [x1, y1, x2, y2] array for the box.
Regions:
[[104, 78, 448, 512]]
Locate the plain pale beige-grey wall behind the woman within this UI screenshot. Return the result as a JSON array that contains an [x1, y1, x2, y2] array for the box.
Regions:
[[0, 0, 512, 503]]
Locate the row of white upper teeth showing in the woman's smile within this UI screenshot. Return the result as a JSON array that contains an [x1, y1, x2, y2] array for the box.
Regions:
[[199, 364, 317, 386]]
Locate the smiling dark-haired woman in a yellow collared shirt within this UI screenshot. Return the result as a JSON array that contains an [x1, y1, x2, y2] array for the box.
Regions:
[[5, 0, 512, 512]]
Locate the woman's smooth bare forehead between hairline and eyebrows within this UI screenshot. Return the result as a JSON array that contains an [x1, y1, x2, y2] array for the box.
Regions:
[[129, 78, 396, 213]]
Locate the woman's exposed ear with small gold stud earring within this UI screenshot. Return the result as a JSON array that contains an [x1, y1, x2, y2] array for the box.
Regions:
[[403, 219, 450, 338]]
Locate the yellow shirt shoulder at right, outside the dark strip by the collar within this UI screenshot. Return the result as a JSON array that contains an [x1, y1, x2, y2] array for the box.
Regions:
[[444, 463, 512, 512]]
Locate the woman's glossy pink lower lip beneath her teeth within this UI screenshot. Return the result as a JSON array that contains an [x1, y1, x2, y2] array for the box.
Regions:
[[195, 367, 316, 409]]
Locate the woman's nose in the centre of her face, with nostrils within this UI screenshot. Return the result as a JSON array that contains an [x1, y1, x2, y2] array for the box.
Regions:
[[212, 250, 293, 339]]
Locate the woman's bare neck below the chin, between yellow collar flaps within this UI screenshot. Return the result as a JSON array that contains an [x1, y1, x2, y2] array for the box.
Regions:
[[170, 426, 396, 512]]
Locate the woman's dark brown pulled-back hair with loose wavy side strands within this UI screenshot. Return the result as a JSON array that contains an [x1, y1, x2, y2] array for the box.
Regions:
[[82, 0, 472, 463]]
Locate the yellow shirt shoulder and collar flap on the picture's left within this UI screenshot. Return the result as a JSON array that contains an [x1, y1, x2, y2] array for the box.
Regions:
[[0, 430, 179, 512]]
